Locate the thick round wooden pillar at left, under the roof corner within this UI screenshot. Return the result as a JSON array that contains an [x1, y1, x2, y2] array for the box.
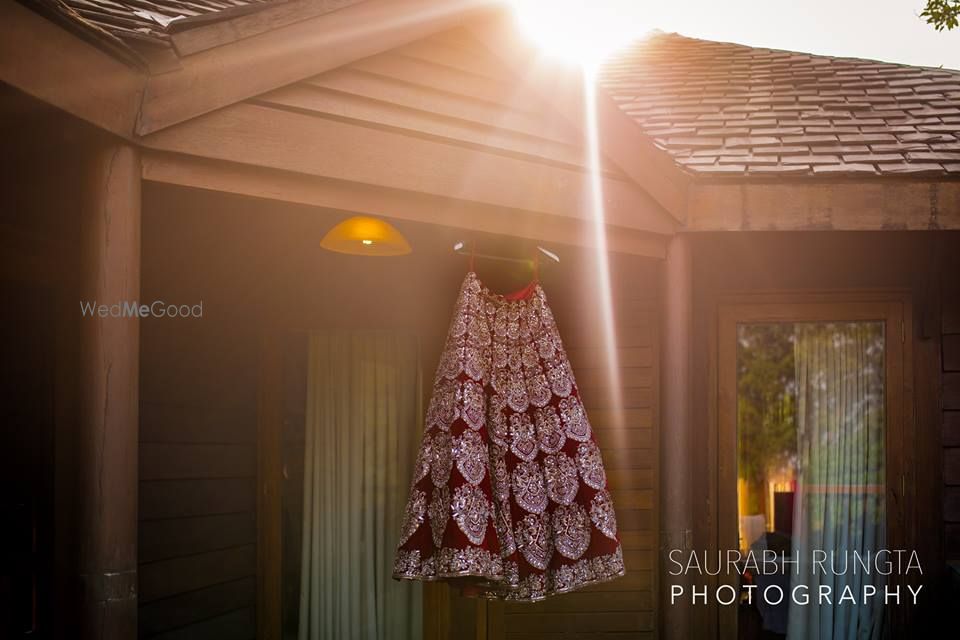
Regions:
[[75, 143, 140, 640]]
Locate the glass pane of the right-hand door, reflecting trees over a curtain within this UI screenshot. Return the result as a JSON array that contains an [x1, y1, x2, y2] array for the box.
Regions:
[[737, 322, 886, 640]]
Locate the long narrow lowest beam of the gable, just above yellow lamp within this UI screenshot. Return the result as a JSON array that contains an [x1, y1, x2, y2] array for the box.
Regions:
[[143, 151, 669, 258]]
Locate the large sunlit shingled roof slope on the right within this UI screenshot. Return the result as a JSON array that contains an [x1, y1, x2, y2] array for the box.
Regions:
[[600, 34, 960, 178]]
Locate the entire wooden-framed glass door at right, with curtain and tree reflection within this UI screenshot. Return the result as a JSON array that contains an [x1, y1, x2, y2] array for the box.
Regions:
[[718, 303, 903, 640]]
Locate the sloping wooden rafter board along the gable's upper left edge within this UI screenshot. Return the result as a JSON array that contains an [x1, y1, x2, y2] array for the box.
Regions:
[[137, 0, 495, 135]]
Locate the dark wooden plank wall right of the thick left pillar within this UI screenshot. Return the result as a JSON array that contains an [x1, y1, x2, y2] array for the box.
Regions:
[[138, 199, 256, 640]]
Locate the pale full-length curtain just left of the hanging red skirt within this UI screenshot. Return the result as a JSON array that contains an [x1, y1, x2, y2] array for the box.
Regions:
[[299, 332, 422, 640]]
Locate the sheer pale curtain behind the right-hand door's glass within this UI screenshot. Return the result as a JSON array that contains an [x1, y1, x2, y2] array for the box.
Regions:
[[787, 322, 886, 640]]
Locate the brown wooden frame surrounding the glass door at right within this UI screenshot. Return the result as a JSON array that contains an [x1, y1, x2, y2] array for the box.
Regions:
[[708, 290, 916, 640]]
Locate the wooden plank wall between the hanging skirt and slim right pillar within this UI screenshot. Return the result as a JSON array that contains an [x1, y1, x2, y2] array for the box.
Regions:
[[498, 260, 659, 640]]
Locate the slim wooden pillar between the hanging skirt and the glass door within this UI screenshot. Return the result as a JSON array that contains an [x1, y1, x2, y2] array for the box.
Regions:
[[660, 234, 694, 639]]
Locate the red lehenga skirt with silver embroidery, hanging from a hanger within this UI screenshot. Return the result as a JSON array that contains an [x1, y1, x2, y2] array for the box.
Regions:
[[394, 271, 624, 601]]
